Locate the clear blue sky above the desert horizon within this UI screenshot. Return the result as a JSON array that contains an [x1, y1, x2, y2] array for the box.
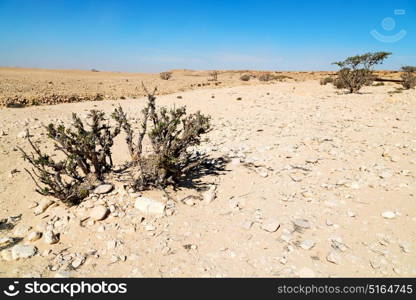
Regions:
[[0, 0, 416, 72]]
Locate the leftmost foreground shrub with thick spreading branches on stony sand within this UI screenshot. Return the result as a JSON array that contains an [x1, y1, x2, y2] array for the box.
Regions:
[[19, 110, 120, 205]]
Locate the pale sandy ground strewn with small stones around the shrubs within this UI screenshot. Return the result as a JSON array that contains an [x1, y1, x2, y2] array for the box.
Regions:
[[0, 76, 416, 277]]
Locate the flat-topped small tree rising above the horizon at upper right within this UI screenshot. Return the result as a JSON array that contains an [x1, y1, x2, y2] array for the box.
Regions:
[[333, 52, 391, 93]]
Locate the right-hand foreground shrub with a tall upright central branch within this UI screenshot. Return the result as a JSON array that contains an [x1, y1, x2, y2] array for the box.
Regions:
[[113, 83, 210, 190]]
